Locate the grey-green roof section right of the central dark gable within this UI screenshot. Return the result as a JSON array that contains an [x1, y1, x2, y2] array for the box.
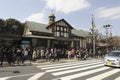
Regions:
[[72, 29, 90, 37]]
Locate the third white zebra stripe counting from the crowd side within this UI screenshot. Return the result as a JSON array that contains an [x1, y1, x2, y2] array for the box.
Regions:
[[46, 62, 102, 72]]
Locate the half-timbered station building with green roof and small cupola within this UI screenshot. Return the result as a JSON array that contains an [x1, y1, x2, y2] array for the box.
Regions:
[[22, 14, 90, 49]]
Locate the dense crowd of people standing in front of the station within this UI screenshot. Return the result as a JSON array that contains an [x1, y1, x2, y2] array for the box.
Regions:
[[0, 46, 106, 66]]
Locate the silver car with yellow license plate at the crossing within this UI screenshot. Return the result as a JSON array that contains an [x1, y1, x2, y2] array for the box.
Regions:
[[104, 50, 120, 67]]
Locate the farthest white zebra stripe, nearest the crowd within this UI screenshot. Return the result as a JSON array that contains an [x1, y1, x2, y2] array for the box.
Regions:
[[37, 60, 102, 68]]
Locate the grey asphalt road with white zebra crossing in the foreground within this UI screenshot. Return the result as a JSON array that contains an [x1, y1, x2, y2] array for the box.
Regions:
[[0, 59, 120, 80]]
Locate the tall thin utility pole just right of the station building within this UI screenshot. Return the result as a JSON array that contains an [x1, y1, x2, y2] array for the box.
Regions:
[[91, 14, 96, 57]]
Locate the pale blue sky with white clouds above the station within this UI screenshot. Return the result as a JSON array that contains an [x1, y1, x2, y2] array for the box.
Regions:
[[0, 0, 120, 36]]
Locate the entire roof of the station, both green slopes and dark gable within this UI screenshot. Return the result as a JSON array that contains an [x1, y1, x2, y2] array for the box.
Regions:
[[25, 19, 90, 37]]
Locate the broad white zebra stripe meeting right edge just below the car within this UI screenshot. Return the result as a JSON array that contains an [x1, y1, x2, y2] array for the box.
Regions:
[[86, 69, 120, 80]]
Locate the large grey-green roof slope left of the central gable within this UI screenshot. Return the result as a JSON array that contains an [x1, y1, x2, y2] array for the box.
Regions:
[[25, 21, 51, 33]]
